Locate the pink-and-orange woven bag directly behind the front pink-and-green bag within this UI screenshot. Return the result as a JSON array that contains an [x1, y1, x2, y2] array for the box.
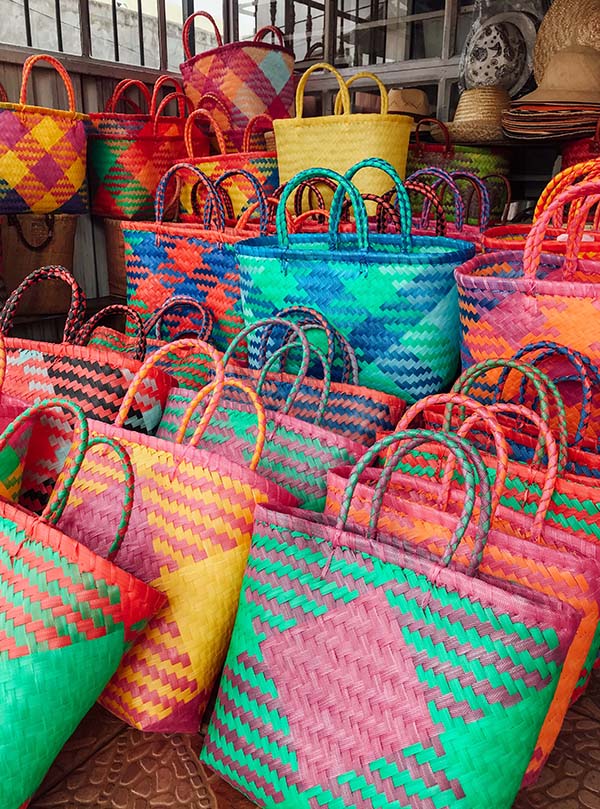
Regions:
[[326, 394, 600, 783]]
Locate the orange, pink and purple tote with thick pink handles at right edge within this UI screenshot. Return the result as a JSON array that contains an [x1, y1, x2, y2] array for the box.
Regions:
[[456, 181, 600, 368]]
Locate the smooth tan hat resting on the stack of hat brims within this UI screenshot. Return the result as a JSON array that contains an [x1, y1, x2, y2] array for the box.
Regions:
[[519, 45, 600, 104]]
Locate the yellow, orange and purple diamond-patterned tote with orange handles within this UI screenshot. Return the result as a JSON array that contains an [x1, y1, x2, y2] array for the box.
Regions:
[[0, 54, 89, 214]]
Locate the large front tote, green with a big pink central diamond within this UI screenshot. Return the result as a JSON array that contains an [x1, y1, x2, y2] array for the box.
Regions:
[[201, 431, 579, 809]]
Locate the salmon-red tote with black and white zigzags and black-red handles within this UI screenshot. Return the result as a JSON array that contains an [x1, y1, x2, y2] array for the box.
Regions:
[[0, 267, 172, 511]]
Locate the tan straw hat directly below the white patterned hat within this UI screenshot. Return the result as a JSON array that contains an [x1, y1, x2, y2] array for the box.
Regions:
[[432, 87, 510, 143]]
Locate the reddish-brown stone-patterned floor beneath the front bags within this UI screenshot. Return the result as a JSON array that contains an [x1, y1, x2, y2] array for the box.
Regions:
[[30, 672, 600, 809]]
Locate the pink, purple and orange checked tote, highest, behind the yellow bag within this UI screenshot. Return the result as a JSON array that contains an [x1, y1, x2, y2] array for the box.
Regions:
[[181, 11, 294, 152]]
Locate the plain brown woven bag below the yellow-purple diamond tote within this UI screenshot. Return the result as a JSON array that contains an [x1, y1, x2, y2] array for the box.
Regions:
[[0, 214, 78, 315]]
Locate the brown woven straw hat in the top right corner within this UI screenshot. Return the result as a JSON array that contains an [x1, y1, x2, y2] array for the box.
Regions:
[[533, 0, 600, 84]]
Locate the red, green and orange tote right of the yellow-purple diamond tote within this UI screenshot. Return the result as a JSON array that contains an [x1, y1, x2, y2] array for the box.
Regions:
[[89, 76, 196, 219]]
